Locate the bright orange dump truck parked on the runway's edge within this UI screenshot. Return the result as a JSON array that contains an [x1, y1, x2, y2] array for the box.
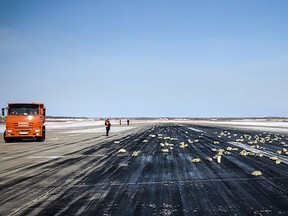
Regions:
[[2, 103, 46, 143]]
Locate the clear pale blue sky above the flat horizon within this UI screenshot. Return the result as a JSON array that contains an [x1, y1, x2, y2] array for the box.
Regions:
[[0, 0, 288, 117]]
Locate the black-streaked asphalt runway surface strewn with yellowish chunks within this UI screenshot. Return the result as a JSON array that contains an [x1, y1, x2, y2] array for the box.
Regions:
[[0, 123, 288, 216]]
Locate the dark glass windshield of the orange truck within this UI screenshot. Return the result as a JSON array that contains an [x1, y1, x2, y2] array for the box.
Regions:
[[8, 104, 39, 115]]
